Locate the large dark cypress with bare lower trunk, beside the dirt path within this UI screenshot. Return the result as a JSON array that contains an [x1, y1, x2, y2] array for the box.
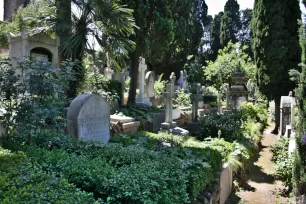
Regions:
[[251, 0, 301, 133]]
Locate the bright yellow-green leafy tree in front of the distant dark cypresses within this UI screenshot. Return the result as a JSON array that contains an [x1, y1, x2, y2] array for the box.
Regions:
[[204, 42, 255, 90]]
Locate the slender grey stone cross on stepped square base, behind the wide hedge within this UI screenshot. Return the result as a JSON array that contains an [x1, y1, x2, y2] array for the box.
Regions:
[[162, 72, 176, 130]]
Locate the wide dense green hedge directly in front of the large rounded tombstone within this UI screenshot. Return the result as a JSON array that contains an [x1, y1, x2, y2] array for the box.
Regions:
[[0, 131, 237, 203]]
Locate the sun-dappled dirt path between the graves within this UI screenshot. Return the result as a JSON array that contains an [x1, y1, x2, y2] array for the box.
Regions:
[[228, 126, 290, 204]]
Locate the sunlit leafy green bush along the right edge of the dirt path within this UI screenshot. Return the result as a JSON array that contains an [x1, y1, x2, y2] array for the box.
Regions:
[[270, 137, 293, 189]]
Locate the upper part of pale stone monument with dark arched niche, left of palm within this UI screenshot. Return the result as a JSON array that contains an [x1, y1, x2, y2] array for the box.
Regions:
[[8, 31, 60, 67]]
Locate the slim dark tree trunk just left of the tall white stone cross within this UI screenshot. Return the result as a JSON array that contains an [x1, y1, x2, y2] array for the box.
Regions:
[[128, 49, 140, 104]]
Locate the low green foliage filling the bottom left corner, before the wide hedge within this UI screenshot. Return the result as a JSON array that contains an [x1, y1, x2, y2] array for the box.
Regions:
[[0, 147, 102, 204]]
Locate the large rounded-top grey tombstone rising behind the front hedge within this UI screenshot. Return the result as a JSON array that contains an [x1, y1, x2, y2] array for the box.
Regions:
[[67, 94, 110, 144]]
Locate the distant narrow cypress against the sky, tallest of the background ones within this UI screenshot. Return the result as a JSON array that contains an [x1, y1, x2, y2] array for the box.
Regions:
[[220, 0, 241, 48]]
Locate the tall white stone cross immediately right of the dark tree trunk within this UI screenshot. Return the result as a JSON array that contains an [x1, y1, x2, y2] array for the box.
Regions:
[[136, 57, 152, 106]]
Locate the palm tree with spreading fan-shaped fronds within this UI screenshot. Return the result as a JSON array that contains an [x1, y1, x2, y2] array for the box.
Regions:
[[32, 0, 136, 98]]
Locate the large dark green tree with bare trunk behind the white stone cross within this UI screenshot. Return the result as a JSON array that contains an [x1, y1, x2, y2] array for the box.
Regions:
[[121, 0, 207, 103]]
